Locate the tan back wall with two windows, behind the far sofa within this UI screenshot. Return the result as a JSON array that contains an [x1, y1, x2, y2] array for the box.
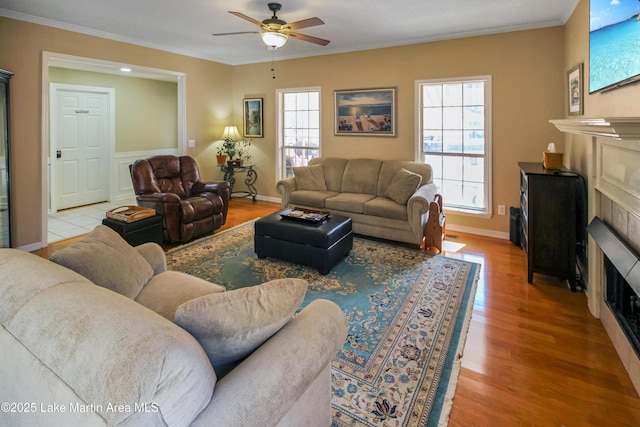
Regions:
[[233, 27, 565, 236]]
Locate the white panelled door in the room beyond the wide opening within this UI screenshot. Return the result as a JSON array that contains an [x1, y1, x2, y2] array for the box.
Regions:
[[50, 84, 113, 212]]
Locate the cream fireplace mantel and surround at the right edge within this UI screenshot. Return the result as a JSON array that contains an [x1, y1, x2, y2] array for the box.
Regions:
[[551, 117, 640, 394]]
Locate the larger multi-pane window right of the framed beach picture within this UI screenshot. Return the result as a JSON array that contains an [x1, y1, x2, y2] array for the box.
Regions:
[[416, 76, 491, 215]]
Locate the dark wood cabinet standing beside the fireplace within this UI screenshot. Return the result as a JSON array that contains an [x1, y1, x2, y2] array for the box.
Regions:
[[518, 162, 582, 291]]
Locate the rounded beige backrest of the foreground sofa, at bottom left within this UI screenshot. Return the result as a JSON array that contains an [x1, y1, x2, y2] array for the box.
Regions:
[[0, 250, 216, 426]]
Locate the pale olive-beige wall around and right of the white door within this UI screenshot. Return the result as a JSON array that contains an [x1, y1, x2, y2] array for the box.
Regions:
[[49, 67, 178, 152]]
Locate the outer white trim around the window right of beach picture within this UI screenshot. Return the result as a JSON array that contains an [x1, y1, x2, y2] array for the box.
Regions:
[[414, 75, 493, 218]]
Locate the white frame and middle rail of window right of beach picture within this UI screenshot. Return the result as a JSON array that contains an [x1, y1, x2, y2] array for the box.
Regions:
[[415, 75, 493, 218]]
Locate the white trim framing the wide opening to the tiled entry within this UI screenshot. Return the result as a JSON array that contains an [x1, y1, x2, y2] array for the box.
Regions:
[[40, 51, 187, 247]]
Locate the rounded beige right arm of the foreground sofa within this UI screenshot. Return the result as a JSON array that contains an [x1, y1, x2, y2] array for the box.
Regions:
[[193, 300, 347, 426]]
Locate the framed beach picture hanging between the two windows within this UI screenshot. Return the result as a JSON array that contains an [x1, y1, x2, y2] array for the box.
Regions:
[[334, 87, 396, 136]]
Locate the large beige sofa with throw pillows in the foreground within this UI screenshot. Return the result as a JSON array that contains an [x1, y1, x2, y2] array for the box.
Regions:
[[0, 226, 347, 427]]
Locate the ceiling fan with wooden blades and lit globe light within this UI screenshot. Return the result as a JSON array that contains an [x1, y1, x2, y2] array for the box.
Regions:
[[213, 3, 329, 49]]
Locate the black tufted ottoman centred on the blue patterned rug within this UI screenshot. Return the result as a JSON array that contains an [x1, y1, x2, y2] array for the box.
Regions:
[[254, 213, 353, 275]]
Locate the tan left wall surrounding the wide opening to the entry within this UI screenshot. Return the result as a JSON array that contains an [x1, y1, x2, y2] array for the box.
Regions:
[[0, 17, 234, 247]]
